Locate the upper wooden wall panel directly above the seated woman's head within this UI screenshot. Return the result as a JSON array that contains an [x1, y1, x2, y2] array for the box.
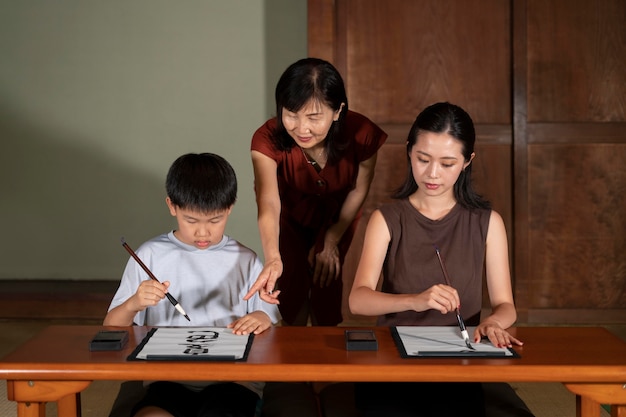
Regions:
[[337, 0, 511, 123]]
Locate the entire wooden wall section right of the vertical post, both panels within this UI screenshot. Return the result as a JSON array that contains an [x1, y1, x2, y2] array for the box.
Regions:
[[516, 0, 626, 323]]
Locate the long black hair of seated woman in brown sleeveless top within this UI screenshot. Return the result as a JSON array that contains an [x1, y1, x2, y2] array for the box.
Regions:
[[392, 103, 491, 209]]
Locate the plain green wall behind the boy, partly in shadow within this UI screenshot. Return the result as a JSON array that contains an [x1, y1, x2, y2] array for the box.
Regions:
[[0, 0, 306, 280]]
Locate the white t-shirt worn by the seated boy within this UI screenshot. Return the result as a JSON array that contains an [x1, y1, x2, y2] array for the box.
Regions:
[[109, 232, 280, 327]]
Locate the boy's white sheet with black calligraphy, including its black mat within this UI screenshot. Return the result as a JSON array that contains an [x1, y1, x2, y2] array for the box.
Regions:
[[128, 327, 254, 361]]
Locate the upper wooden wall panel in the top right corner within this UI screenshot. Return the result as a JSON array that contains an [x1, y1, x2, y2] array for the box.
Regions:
[[527, 0, 626, 123]]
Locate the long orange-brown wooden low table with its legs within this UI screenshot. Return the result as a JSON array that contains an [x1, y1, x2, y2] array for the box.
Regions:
[[0, 325, 626, 417]]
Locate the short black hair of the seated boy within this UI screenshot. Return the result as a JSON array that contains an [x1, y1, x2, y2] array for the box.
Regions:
[[165, 153, 237, 213]]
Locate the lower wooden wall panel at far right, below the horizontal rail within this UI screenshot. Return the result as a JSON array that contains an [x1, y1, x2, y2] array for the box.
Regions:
[[528, 144, 626, 310]]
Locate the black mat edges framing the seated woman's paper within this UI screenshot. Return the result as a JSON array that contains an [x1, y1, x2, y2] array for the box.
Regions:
[[389, 326, 521, 359]]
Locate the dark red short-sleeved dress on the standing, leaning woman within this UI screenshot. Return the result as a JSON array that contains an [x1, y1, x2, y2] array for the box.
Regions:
[[251, 111, 387, 326]]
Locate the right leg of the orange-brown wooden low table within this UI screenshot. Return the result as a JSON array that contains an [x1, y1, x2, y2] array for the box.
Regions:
[[564, 384, 626, 417]]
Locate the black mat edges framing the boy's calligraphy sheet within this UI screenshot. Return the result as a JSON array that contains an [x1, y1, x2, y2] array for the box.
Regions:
[[126, 327, 254, 362]]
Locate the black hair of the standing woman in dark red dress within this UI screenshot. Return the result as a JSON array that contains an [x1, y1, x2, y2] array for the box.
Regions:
[[272, 58, 348, 164]]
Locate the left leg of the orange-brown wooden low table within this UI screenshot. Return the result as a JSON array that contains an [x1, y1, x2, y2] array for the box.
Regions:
[[7, 381, 91, 417]]
